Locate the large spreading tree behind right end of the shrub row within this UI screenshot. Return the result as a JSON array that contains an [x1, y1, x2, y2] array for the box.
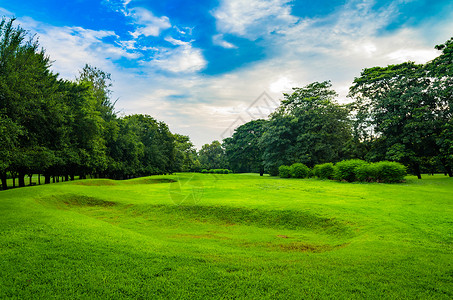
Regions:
[[350, 62, 442, 178]]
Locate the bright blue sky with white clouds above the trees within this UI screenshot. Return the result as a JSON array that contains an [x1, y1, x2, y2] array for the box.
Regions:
[[0, 0, 453, 148]]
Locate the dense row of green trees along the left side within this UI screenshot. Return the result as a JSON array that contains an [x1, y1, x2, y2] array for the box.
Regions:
[[0, 18, 201, 189]]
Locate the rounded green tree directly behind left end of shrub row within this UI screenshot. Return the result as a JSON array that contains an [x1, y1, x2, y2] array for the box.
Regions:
[[260, 81, 351, 175]]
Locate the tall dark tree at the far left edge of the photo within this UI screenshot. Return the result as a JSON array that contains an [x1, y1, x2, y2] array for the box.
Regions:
[[0, 19, 62, 186]]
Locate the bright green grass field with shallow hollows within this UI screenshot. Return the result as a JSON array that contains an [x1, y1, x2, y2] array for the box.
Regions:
[[0, 174, 453, 299]]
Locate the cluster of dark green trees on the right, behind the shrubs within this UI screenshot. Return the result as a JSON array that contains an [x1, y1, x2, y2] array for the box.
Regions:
[[215, 38, 453, 178]]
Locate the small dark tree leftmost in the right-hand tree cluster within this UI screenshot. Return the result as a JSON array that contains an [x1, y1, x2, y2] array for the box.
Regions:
[[223, 120, 267, 175]]
